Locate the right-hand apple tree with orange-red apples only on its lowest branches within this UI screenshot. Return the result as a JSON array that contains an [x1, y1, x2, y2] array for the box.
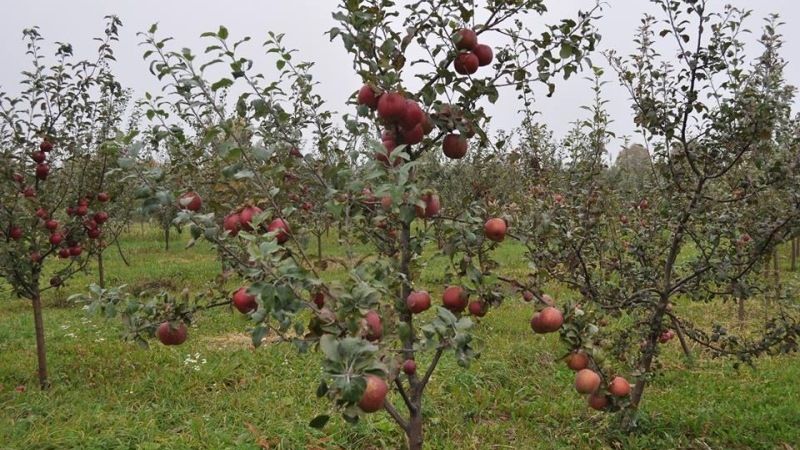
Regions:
[[520, 0, 800, 429]]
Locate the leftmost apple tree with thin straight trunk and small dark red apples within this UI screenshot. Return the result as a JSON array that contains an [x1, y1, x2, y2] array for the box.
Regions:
[[0, 16, 127, 389]]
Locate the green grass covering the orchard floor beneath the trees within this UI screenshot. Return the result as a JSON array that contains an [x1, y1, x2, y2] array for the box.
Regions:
[[0, 227, 800, 449]]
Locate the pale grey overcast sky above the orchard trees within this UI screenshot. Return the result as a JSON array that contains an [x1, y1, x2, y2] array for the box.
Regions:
[[0, 0, 800, 158]]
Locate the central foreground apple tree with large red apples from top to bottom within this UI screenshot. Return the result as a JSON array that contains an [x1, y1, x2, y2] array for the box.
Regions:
[[87, 0, 599, 449]]
